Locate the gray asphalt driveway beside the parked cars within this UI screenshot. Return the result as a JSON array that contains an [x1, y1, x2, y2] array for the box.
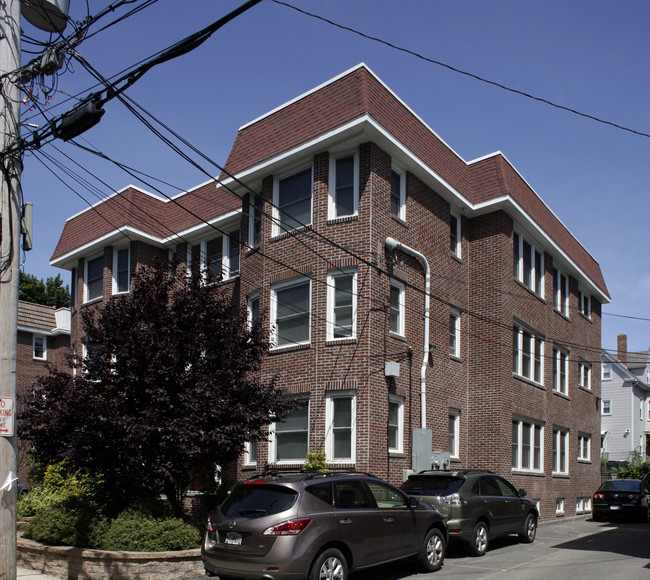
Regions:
[[195, 518, 650, 580]]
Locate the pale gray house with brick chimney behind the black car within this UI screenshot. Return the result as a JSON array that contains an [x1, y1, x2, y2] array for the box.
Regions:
[[600, 334, 650, 461]]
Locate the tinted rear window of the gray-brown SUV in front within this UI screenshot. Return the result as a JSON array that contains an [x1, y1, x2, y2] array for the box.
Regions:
[[221, 484, 298, 518]]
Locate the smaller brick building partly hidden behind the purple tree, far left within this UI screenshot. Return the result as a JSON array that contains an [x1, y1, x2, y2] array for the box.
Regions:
[[16, 300, 70, 483]]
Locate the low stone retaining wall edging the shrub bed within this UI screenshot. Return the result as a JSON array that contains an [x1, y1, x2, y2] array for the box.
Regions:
[[17, 536, 205, 580]]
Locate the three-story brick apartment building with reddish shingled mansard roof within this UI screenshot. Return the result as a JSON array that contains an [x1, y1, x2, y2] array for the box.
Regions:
[[51, 65, 610, 518]]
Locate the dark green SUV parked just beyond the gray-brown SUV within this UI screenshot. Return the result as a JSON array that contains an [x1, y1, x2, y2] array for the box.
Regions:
[[402, 469, 539, 556]]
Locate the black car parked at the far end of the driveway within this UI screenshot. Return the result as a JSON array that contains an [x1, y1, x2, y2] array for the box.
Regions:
[[591, 478, 650, 522]]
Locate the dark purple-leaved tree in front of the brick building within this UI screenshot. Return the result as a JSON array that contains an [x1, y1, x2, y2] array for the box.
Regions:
[[19, 265, 295, 513]]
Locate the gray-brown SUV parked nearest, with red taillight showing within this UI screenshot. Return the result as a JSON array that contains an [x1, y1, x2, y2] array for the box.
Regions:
[[201, 471, 447, 580]]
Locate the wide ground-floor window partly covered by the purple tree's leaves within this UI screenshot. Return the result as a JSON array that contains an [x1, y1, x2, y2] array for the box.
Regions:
[[269, 398, 309, 463]]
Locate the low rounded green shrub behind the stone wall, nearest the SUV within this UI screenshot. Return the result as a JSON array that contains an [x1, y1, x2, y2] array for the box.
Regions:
[[98, 509, 201, 552]]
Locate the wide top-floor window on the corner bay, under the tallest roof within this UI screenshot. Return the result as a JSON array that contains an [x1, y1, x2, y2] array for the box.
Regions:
[[273, 167, 313, 235]]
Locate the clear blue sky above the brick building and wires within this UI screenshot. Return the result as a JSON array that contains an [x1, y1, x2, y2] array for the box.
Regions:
[[16, 0, 650, 350]]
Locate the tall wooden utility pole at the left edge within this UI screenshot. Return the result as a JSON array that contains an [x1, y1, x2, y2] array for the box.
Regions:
[[0, 0, 22, 580]]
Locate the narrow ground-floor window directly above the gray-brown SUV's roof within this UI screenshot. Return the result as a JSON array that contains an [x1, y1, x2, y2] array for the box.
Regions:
[[325, 392, 356, 463]]
